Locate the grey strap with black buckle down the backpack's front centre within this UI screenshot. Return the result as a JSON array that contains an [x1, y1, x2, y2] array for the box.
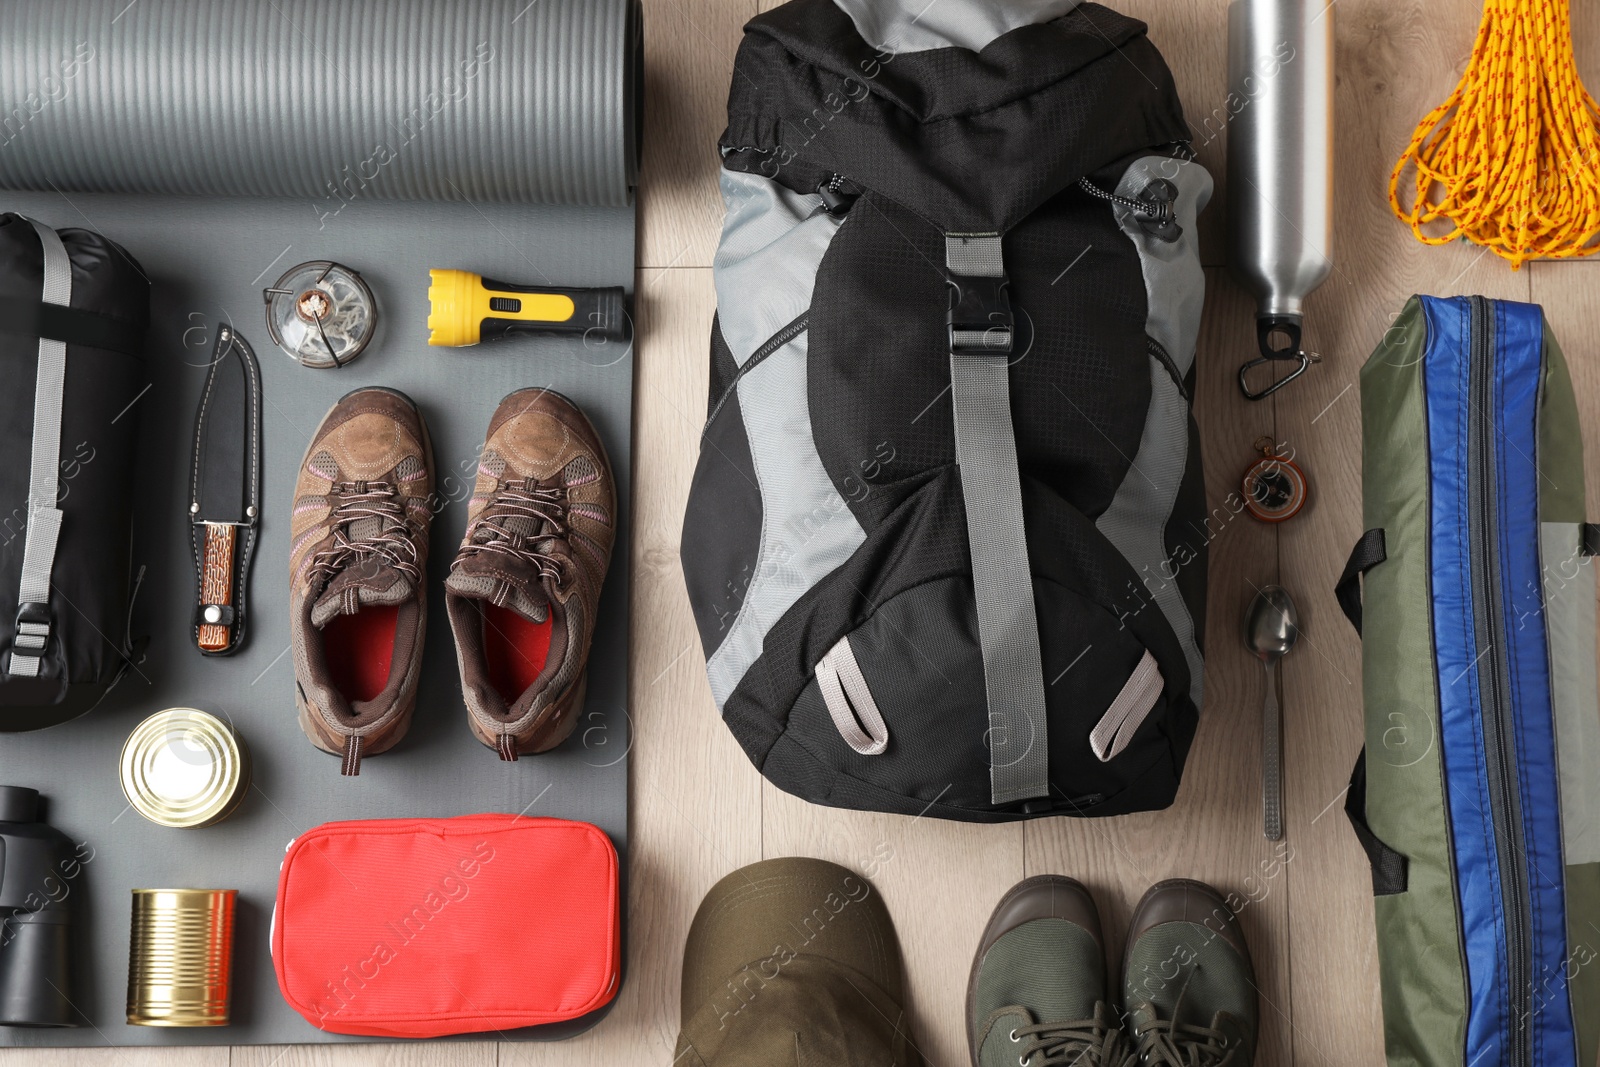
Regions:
[[944, 234, 1050, 805]]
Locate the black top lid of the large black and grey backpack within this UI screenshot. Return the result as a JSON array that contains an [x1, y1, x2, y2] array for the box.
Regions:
[[722, 0, 1190, 232]]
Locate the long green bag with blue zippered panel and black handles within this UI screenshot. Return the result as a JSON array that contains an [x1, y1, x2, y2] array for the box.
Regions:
[[1339, 296, 1600, 1067]]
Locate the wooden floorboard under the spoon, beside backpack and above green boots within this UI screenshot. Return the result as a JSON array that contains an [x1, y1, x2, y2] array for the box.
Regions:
[[1027, 269, 1290, 1067]]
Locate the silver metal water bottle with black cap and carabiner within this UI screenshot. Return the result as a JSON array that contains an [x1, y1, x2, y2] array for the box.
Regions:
[[1227, 0, 1336, 400]]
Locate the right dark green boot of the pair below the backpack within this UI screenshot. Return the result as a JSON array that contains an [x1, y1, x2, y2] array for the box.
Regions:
[[1122, 878, 1258, 1067]]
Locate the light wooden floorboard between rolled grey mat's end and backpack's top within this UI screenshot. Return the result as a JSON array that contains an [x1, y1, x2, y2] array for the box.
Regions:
[[638, 0, 755, 267]]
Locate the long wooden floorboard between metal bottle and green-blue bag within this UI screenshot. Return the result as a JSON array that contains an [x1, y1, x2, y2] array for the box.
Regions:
[[1277, 0, 1528, 1067]]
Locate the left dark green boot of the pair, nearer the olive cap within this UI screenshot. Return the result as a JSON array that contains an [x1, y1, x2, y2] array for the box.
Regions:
[[966, 875, 1134, 1067]]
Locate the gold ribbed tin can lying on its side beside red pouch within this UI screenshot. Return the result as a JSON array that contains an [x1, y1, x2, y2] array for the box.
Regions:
[[128, 889, 238, 1027]]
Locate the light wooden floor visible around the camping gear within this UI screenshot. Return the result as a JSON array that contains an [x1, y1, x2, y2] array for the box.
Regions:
[[18, 0, 1600, 1067]]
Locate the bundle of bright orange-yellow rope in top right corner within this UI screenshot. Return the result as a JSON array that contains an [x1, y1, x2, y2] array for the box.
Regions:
[[1389, 0, 1600, 270]]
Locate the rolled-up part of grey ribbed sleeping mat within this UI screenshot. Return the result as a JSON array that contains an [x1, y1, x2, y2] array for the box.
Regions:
[[0, 0, 642, 211]]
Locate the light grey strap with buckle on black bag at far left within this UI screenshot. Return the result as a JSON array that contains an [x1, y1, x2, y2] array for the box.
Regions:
[[10, 219, 72, 678]]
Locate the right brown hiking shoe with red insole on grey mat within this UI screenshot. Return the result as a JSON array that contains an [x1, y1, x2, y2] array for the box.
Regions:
[[445, 389, 616, 760]]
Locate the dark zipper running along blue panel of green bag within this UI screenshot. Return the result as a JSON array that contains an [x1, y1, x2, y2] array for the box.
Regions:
[[1467, 296, 1533, 1067]]
